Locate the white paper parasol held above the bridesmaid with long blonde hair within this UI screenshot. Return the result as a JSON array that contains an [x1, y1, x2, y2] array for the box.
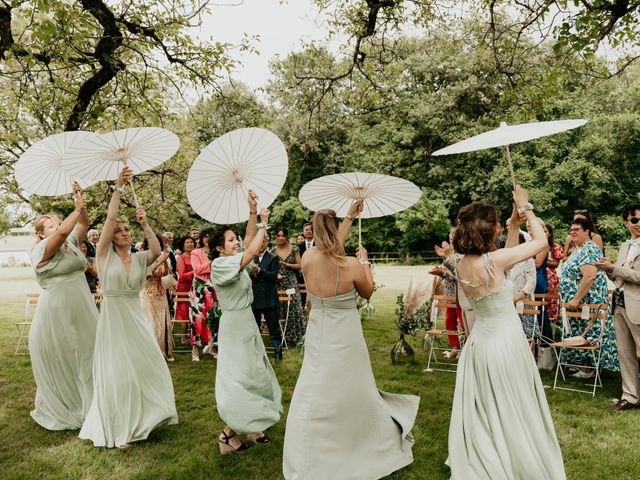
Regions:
[[298, 172, 422, 244]]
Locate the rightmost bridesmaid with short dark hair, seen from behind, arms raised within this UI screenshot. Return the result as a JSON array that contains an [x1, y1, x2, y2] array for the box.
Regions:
[[447, 186, 566, 480]]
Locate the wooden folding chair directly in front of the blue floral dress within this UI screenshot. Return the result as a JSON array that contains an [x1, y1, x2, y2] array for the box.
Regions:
[[551, 303, 609, 397]]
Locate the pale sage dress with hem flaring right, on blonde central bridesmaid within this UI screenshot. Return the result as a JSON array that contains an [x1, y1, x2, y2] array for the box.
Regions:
[[282, 282, 418, 480]]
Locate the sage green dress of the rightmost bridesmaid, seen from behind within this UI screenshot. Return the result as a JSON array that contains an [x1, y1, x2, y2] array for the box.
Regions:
[[448, 254, 566, 480]]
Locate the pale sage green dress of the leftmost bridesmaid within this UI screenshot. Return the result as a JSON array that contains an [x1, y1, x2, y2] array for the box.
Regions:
[[29, 232, 98, 430]]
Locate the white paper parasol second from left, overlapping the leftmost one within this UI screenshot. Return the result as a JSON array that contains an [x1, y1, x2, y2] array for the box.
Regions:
[[62, 127, 180, 206]]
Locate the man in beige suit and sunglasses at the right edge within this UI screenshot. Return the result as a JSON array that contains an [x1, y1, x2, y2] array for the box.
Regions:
[[595, 203, 640, 412]]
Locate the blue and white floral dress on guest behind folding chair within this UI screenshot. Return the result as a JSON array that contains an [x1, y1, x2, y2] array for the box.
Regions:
[[559, 244, 620, 372]]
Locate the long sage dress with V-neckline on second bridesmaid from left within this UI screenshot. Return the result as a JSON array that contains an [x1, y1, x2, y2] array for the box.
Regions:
[[80, 248, 178, 447]]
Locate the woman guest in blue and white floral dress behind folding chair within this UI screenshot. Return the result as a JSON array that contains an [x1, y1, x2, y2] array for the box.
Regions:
[[559, 218, 620, 372]]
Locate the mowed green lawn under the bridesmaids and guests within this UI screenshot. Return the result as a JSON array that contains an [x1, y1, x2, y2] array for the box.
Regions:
[[0, 267, 640, 480]]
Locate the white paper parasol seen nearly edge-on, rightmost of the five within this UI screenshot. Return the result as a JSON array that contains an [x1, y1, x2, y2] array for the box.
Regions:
[[432, 119, 587, 190]]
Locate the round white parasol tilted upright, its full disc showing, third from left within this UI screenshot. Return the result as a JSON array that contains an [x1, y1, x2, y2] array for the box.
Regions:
[[187, 128, 289, 224]]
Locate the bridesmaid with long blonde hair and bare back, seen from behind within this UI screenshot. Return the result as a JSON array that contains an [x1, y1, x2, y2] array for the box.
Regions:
[[283, 201, 420, 480]]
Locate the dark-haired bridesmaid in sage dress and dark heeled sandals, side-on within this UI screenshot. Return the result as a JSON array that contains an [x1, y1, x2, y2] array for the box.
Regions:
[[209, 190, 282, 455]]
